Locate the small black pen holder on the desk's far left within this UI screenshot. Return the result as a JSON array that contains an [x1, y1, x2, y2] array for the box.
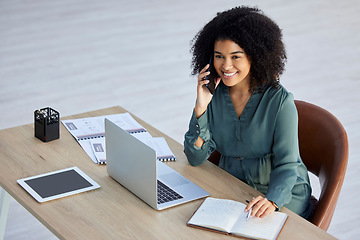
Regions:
[[34, 107, 60, 142]]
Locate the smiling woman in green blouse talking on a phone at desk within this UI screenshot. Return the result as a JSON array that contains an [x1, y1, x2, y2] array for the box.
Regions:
[[184, 7, 312, 218]]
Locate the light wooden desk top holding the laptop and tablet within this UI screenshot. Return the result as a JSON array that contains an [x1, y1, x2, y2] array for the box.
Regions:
[[0, 107, 334, 240]]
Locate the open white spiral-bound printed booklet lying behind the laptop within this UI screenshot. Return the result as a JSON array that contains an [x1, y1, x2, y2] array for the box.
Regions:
[[61, 113, 176, 164]]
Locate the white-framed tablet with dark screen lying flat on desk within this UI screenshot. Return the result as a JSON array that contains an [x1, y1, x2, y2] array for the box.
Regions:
[[17, 167, 100, 202]]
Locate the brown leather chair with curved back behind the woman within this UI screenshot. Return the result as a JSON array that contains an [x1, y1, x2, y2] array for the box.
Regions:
[[208, 100, 349, 231]]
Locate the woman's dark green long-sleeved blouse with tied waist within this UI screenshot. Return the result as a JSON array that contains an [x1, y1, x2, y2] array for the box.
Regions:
[[184, 82, 311, 218]]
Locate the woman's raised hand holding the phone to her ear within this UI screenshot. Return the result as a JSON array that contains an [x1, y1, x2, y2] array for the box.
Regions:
[[195, 64, 220, 118]]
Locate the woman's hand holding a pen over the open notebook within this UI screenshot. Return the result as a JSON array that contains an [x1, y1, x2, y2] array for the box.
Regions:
[[244, 196, 276, 218]]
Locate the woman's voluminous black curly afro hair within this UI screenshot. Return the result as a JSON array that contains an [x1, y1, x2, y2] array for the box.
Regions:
[[191, 6, 286, 91]]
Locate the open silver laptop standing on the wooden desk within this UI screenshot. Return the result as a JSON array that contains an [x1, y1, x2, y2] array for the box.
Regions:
[[105, 119, 209, 210]]
